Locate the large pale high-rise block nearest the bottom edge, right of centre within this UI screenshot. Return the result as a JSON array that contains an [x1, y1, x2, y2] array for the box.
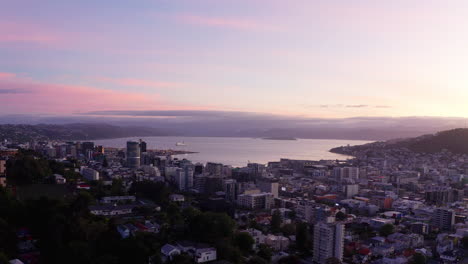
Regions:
[[314, 222, 345, 264]]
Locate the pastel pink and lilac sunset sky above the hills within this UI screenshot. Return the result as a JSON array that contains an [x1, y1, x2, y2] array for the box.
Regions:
[[0, 0, 468, 118]]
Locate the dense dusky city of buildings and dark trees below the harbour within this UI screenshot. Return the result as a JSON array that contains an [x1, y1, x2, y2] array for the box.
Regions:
[[0, 130, 468, 264]]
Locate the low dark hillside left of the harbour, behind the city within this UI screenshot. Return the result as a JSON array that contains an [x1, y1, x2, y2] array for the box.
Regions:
[[0, 123, 170, 142]]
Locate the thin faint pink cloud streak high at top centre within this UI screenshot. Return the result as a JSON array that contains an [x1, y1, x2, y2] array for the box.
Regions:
[[177, 14, 280, 31]]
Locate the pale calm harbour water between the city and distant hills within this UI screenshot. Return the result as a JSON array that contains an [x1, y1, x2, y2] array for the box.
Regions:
[[94, 137, 370, 167]]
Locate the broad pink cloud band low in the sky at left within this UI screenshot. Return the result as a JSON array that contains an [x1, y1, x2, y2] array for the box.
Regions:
[[0, 73, 169, 114]]
